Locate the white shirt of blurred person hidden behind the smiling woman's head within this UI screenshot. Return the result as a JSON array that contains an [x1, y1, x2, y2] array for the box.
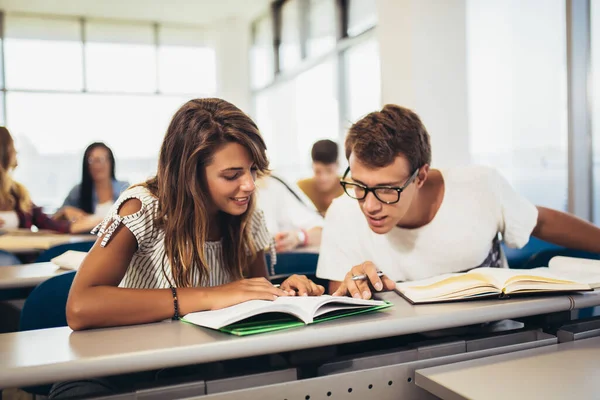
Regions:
[[256, 176, 324, 235]]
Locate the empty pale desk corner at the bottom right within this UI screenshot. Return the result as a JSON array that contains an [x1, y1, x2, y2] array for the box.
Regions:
[[415, 337, 600, 400]]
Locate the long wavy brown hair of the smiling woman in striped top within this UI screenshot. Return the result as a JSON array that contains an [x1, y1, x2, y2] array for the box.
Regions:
[[144, 98, 269, 287]]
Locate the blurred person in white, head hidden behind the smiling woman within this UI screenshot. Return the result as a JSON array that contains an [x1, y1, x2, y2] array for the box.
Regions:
[[256, 175, 323, 252]]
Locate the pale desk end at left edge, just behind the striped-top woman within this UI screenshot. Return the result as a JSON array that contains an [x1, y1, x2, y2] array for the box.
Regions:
[[0, 262, 69, 290]]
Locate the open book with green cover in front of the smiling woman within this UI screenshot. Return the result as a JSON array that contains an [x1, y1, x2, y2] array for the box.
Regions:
[[182, 295, 392, 336]]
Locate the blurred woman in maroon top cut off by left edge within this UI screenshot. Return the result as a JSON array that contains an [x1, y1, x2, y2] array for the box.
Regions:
[[0, 127, 102, 233]]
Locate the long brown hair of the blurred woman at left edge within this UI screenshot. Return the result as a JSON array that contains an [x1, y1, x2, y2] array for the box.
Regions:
[[0, 126, 33, 212]]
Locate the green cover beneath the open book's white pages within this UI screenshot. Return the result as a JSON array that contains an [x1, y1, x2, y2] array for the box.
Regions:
[[213, 301, 393, 336]]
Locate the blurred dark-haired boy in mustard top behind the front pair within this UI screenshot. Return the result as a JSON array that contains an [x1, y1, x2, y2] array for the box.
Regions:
[[298, 139, 344, 216]]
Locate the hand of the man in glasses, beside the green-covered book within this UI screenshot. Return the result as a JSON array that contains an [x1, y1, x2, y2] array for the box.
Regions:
[[333, 261, 396, 300]]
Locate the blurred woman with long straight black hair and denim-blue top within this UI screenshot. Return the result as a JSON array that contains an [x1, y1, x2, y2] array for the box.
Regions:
[[54, 142, 129, 221]]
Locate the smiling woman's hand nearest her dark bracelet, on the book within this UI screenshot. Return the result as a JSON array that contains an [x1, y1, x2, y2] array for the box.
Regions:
[[203, 278, 288, 310]]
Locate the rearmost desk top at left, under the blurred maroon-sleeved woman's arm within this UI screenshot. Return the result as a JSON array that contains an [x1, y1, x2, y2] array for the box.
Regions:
[[0, 231, 97, 254]]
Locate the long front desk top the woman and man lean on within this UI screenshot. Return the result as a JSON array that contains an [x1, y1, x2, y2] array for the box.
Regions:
[[0, 292, 596, 388]]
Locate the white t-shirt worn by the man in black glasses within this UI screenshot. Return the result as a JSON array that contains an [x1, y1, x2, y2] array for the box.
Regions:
[[317, 166, 538, 281]]
